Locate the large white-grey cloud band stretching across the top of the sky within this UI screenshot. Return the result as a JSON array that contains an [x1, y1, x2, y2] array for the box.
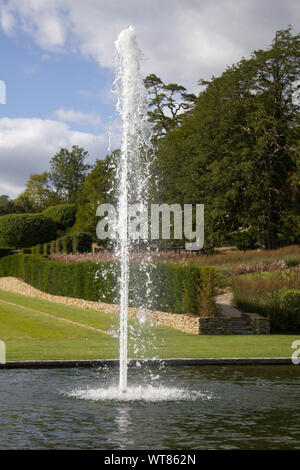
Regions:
[[2, 0, 300, 90]]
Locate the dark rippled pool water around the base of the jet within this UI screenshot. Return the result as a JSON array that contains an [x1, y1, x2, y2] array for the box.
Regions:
[[0, 366, 300, 450]]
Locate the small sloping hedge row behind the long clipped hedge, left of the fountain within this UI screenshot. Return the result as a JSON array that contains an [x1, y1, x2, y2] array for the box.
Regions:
[[31, 232, 93, 255]]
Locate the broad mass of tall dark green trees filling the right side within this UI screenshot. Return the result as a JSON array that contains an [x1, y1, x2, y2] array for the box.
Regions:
[[157, 28, 300, 248]]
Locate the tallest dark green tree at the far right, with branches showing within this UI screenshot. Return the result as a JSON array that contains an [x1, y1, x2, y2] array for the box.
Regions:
[[230, 27, 300, 248]]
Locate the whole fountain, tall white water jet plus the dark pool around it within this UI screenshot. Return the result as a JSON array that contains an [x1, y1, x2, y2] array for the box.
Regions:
[[0, 27, 300, 454]]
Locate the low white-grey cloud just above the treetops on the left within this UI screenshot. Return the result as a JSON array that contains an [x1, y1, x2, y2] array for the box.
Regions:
[[0, 118, 108, 196]]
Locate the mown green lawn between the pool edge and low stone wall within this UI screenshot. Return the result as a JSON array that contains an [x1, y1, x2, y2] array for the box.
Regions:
[[0, 290, 300, 361]]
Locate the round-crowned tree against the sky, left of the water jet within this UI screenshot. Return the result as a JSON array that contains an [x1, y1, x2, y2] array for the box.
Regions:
[[49, 145, 91, 203]]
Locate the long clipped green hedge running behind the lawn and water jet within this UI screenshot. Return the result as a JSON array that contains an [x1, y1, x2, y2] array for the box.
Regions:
[[0, 255, 215, 315]]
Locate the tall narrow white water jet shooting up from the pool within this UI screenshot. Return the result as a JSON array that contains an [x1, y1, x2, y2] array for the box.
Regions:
[[114, 26, 151, 392]]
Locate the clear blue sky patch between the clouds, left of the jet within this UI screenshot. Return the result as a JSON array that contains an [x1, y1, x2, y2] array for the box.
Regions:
[[0, 24, 114, 132]]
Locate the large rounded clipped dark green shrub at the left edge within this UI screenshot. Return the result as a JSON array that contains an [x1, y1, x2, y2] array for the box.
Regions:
[[0, 214, 56, 248]]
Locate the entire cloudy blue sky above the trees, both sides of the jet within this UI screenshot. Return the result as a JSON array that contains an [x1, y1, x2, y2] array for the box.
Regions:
[[0, 0, 300, 197]]
